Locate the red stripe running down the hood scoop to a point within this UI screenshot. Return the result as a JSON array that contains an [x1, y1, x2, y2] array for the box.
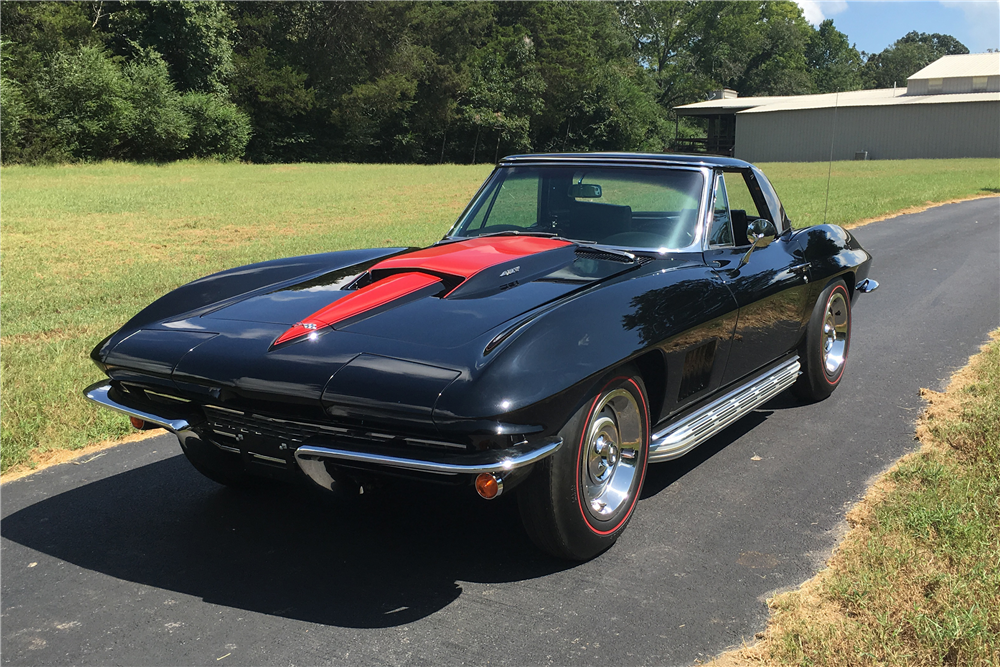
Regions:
[[274, 236, 572, 345]]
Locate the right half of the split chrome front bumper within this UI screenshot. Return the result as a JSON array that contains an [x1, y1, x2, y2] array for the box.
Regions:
[[295, 438, 562, 488]]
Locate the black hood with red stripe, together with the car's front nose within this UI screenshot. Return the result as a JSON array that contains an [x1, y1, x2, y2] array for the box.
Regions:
[[98, 237, 640, 423]]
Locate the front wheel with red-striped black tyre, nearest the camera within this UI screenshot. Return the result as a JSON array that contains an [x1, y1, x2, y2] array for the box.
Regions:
[[518, 367, 649, 560]]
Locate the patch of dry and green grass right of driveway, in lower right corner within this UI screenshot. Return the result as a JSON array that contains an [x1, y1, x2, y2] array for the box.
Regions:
[[715, 330, 1000, 667]]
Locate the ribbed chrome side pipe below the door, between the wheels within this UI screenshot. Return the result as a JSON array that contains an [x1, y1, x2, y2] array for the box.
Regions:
[[649, 356, 802, 463]]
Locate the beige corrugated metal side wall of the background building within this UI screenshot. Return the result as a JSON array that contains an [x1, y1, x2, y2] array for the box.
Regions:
[[735, 102, 1000, 162]]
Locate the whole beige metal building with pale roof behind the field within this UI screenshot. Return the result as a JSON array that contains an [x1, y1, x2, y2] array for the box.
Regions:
[[675, 53, 1000, 162]]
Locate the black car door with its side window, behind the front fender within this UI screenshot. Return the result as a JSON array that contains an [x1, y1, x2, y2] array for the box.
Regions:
[[705, 170, 809, 384]]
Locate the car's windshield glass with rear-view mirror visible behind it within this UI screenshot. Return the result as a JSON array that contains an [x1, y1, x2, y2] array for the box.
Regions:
[[450, 166, 704, 250]]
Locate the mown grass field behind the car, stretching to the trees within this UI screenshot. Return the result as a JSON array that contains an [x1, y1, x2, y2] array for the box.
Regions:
[[0, 160, 1000, 471]]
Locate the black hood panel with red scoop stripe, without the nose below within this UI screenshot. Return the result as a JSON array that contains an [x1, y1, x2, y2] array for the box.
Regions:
[[195, 236, 636, 350]]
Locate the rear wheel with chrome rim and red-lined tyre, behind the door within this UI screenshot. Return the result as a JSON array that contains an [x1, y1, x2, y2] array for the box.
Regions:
[[794, 280, 851, 401]]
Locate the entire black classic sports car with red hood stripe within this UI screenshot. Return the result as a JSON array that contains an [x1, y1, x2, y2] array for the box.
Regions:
[[86, 153, 877, 559]]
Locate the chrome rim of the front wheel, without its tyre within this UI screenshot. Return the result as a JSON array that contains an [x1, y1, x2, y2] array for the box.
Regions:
[[580, 388, 643, 520]]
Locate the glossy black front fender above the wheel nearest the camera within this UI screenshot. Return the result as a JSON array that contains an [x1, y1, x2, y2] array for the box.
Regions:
[[434, 263, 737, 433]]
